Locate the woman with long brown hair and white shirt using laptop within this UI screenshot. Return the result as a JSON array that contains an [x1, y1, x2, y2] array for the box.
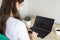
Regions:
[[0, 0, 36, 40]]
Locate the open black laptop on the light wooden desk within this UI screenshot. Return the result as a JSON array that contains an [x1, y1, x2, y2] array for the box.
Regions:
[[30, 16, 54, 38]]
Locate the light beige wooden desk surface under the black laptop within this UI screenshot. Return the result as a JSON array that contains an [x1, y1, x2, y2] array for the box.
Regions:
[[30, 18, 60, 40]]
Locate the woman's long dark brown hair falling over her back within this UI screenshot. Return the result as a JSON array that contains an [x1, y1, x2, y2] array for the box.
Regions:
[[0, 0, 24, 35]]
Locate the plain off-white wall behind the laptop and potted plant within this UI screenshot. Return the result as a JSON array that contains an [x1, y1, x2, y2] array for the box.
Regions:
[[28, 0, 60, 24]]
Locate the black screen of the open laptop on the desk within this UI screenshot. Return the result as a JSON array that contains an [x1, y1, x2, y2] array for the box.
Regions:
[[34, 16, 54, 31]]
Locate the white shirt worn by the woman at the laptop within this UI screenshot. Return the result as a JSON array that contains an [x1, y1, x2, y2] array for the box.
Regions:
[[5, 17, 30, 40]]
